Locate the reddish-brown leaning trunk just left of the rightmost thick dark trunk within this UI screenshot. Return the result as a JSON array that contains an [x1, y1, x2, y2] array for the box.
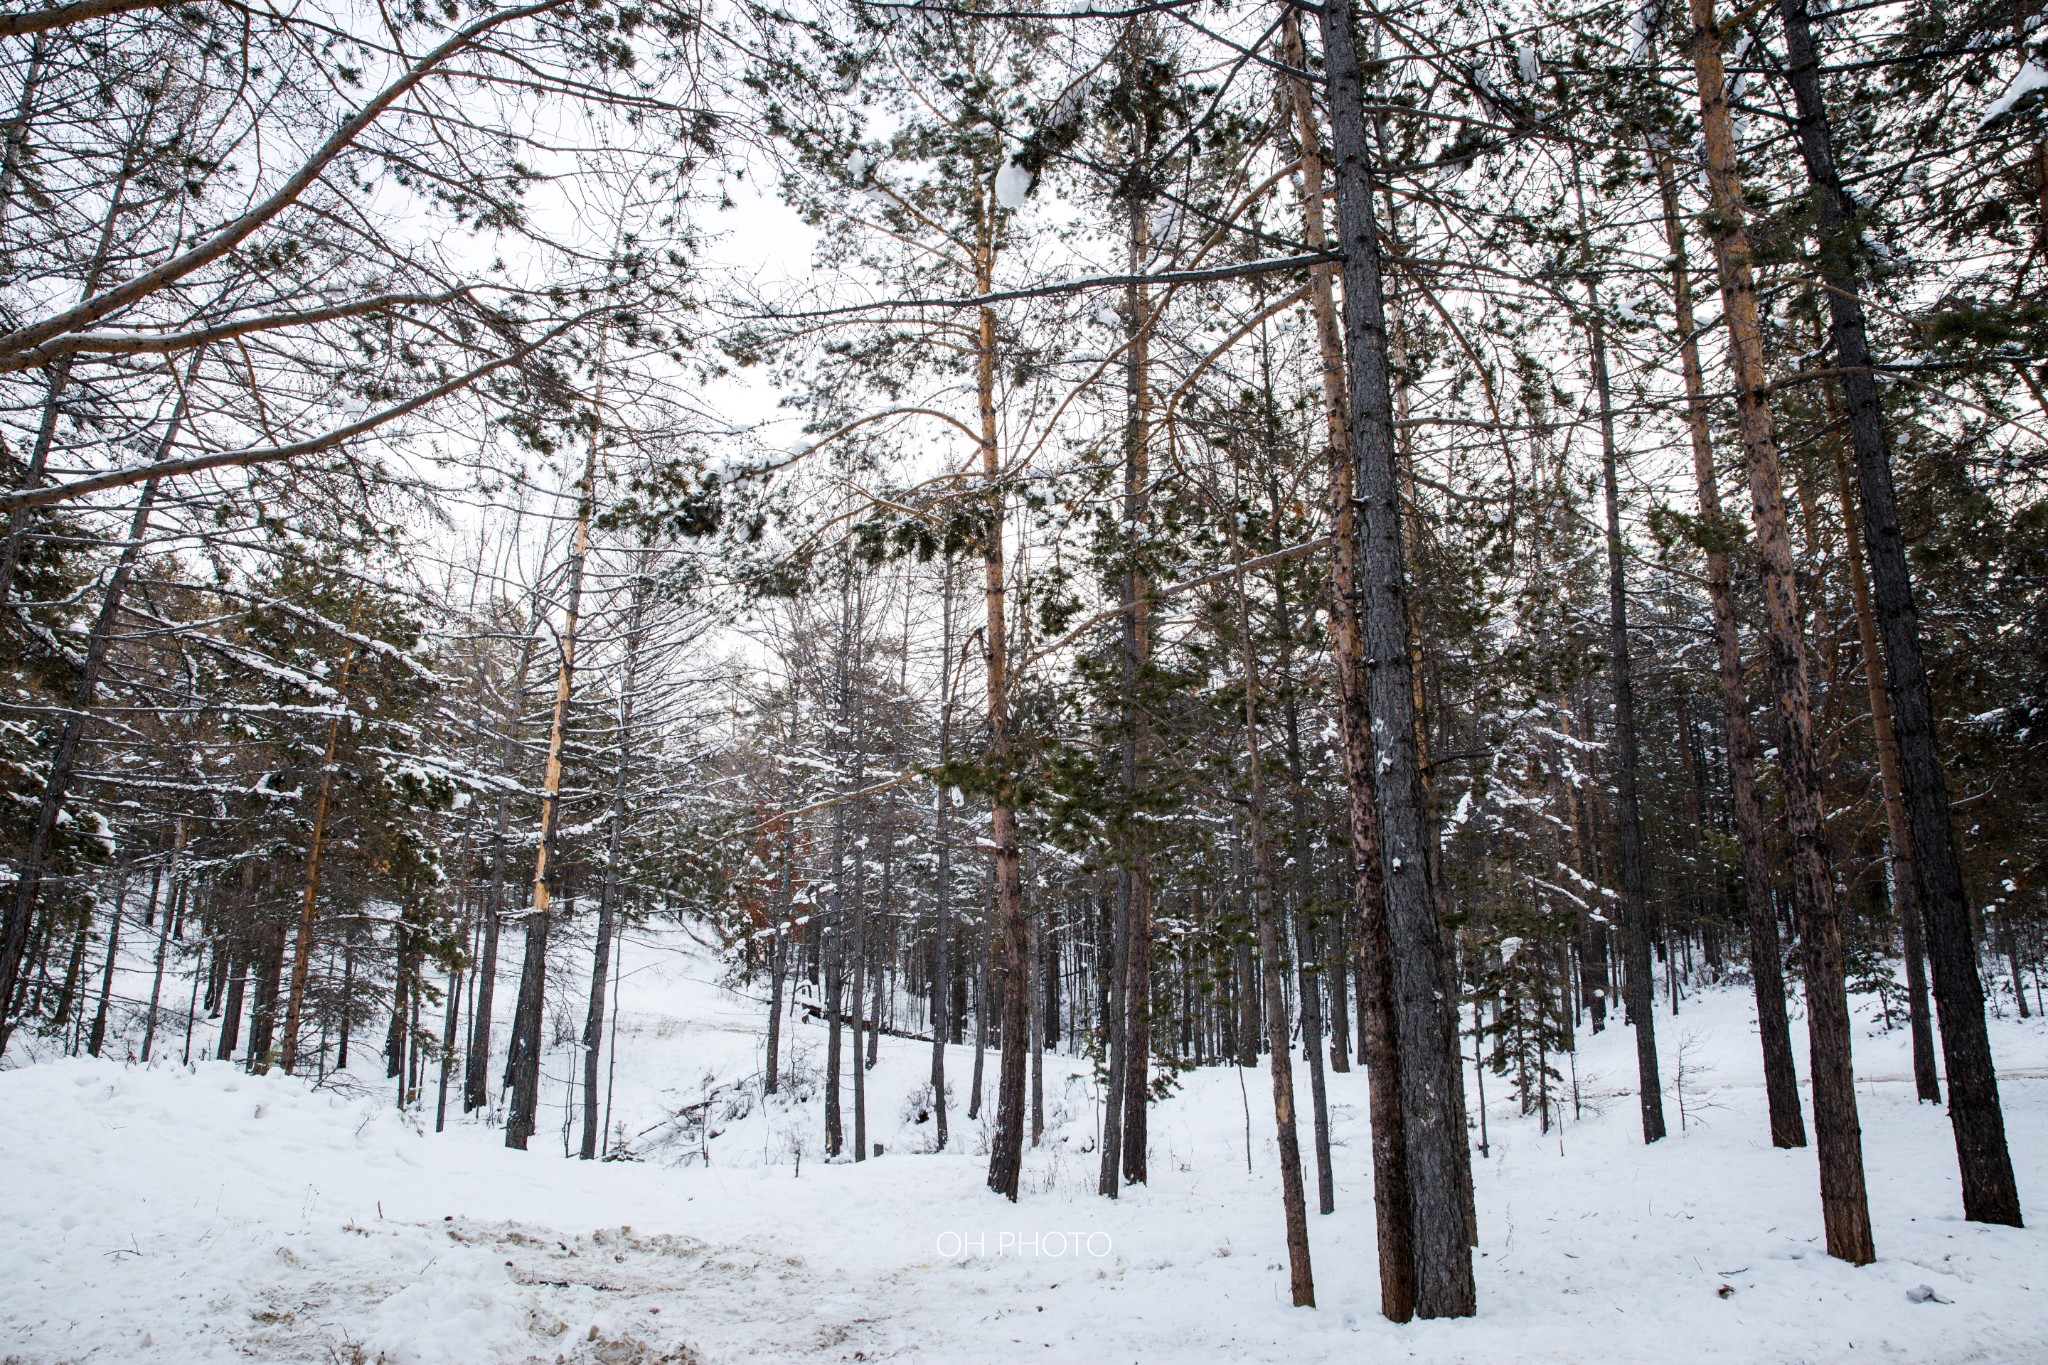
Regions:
[[1692, 0, 1876, 1265]]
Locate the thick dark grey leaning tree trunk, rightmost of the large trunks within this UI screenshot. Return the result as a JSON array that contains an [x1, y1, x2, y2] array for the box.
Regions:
[[1780, 0, 2021, 1228]]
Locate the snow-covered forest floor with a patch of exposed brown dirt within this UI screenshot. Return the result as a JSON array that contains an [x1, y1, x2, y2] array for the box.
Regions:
[[0, 937, 2048, 1365]]
